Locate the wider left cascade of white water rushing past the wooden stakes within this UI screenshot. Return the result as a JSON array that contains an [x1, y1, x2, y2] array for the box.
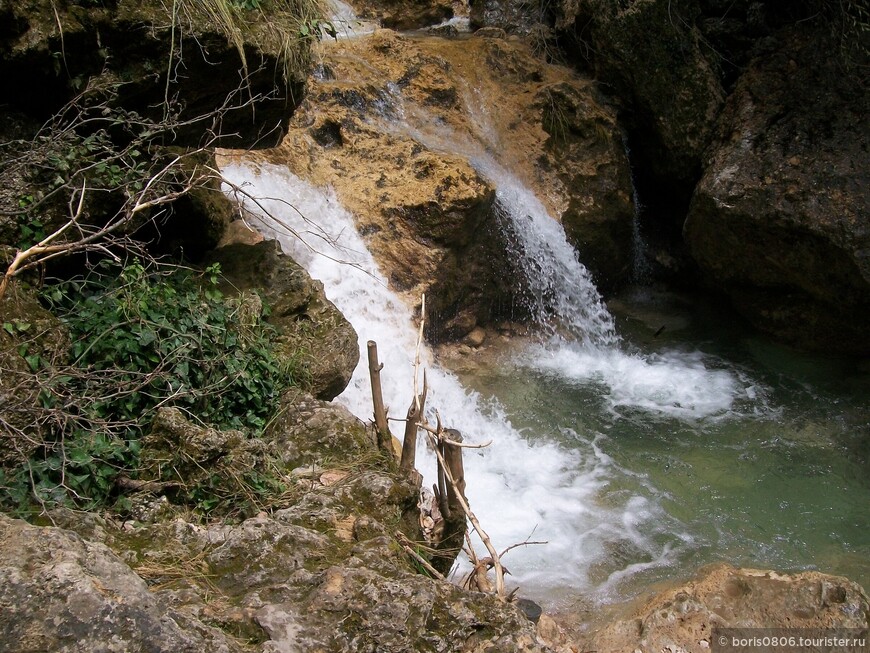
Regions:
[[222, 164, 689, 602]]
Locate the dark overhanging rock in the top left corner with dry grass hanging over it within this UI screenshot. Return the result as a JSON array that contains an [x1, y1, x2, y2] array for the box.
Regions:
[[0, 0, 309, 147]]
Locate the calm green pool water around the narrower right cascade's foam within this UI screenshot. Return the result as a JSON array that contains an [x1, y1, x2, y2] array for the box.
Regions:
[[458, 288, 870, 598]]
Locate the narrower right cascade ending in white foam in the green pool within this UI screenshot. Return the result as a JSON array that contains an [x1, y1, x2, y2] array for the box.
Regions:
[[384, 105, 752, 419]]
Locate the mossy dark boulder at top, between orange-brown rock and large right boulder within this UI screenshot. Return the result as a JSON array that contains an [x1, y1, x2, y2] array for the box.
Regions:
[[556, 0, 725, 231]]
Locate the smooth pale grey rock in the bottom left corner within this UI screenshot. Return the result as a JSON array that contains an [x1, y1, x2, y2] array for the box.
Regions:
[[0, 515, 243, 653]]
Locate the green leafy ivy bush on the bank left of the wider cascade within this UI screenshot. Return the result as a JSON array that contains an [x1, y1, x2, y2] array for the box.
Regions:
[[0, 262, 296, 514]]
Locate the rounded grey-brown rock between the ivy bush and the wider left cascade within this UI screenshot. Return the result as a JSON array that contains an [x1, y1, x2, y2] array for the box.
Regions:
[[207, 241, 359, 400]]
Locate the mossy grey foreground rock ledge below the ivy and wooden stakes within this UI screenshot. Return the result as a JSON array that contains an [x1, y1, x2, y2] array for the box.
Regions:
[[22, 448, 550, 653]]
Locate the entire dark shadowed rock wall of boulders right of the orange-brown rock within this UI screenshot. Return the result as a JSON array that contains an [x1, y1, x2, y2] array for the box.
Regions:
[[528, 0, 870, 353]]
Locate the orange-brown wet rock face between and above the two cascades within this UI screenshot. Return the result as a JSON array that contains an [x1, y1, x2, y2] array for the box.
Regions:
[[255, 30, 634, 337]]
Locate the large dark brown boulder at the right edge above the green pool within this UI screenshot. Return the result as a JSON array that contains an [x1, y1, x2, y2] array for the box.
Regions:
[[684, 30, 870, 354]]
